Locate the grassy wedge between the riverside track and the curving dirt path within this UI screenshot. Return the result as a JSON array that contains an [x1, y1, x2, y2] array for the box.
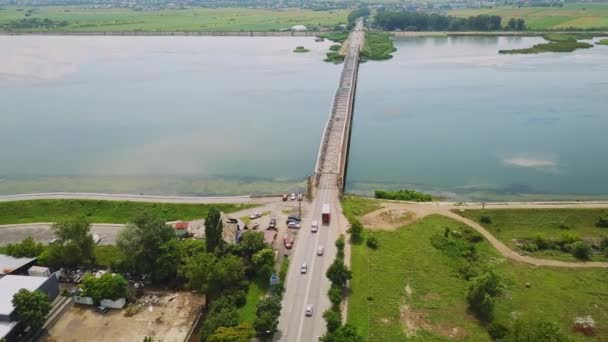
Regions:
[[454, 209, 608, 261]]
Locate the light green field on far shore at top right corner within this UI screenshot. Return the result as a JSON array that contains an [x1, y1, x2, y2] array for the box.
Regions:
[[449, 3, 608, 30]]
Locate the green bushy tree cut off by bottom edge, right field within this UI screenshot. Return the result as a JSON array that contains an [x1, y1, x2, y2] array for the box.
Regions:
[[502, 320, 570, 342]]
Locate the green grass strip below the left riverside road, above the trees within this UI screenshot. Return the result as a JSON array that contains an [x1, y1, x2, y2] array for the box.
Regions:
[[0, 200, 255, 224]]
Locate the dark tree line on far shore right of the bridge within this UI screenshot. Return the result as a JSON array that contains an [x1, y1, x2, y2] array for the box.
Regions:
[[374, 10, 526, 31]]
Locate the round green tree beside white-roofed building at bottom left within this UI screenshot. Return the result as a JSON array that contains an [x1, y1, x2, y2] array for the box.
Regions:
[[12, 289, 51, 330]]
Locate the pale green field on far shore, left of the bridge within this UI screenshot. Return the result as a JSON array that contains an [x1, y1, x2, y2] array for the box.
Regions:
[[0, 6, 348, 31]]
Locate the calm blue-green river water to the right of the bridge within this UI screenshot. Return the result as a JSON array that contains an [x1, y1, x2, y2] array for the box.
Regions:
[[349, 37, 608, 199]]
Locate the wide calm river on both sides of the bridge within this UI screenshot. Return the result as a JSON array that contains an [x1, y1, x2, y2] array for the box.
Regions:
[[0, 36, 608, 199]]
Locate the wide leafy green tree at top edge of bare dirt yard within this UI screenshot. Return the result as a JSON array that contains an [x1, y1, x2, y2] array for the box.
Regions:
[[82, 273, 129, 303]]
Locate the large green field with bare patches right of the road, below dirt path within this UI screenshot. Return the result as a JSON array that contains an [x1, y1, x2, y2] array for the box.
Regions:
[[348, 216, 608, 341]]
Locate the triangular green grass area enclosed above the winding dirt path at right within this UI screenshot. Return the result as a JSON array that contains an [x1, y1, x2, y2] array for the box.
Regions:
[[454, 209, 608, 261]]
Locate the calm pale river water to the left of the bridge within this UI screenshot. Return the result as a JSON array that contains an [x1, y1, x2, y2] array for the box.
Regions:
[[0, 36, 340, 193]]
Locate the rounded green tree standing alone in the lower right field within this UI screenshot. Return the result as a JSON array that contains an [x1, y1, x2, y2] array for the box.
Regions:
[[467, 270, 502, 322]]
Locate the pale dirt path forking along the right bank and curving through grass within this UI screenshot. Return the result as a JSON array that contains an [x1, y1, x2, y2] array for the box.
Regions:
[[361, 202, 608, 268]]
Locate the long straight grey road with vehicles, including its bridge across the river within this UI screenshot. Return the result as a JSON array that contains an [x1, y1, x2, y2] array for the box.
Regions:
[[275, 20, 364, 342]]
